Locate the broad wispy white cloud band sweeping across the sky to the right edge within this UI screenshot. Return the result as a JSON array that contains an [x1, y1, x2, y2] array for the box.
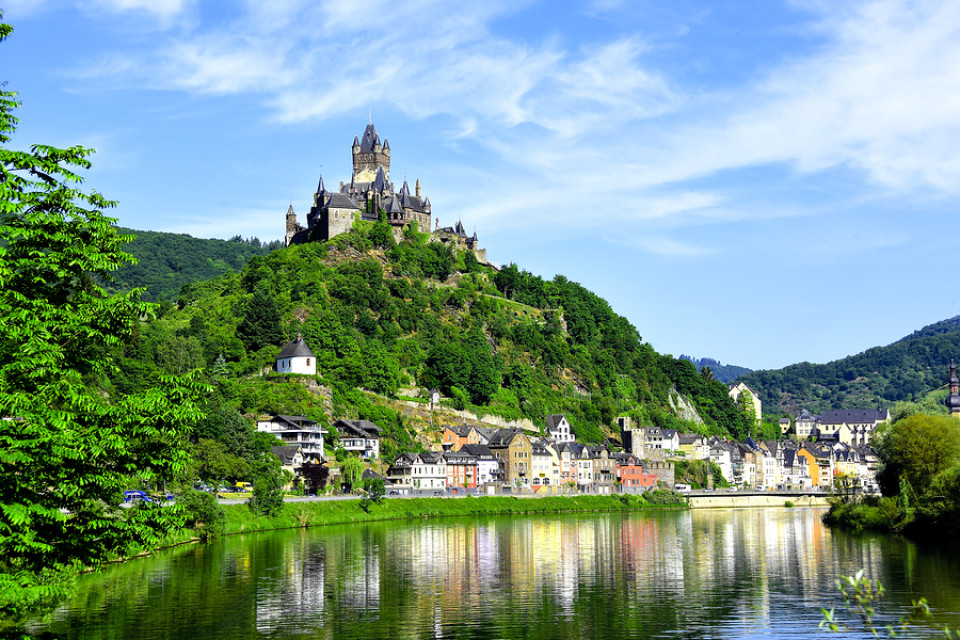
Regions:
[[62, 0, 960, 255]]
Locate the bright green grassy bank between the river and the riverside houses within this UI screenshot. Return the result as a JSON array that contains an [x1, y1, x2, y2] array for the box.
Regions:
[[224, 495, 687, 535]]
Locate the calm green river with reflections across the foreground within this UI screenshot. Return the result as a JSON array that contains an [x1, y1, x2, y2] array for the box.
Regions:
[[33, 509, 960, 640]]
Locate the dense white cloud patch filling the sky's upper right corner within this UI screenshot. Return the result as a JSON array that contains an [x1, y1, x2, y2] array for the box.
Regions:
[[655, 0, 960, 191]]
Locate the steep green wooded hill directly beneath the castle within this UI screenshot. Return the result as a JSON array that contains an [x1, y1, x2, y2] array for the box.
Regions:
[[115, 222, 746, 460]]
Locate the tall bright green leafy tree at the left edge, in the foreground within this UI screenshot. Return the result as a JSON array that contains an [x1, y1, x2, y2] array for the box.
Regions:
[[0, 18, 205, 620]]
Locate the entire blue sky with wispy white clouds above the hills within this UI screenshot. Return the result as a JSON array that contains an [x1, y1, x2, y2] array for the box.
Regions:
[[0, 0, 960, 368]]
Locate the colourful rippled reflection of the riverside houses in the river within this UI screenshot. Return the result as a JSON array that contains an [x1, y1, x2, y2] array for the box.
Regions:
[[248, 509, 908, 637]]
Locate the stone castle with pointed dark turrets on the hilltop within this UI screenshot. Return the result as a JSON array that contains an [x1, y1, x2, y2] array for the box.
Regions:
[[285, 122, 442, 249]]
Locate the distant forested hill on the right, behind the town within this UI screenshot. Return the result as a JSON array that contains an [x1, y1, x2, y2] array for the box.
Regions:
[[739, 316, 960, 415]]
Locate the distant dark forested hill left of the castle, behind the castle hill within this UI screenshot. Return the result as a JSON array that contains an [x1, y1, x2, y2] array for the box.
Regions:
[[106, 229, 283, 302]]
